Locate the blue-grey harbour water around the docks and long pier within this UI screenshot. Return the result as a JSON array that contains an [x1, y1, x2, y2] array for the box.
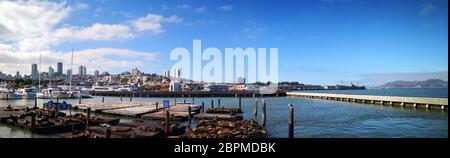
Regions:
[[0, 89, 448, 138]]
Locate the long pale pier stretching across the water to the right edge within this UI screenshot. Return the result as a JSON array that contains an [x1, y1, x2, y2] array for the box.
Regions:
[[286, 92, 448, 110]]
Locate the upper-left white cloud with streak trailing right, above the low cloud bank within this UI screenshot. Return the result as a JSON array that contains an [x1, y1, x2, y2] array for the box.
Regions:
[[0, 0, 182, 52]]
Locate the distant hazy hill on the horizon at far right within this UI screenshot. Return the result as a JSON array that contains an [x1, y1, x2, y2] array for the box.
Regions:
[[380, 79, 448, 88]]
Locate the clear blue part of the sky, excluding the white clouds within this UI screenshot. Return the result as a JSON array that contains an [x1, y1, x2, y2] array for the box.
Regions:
[[0, 0, 448, 85]]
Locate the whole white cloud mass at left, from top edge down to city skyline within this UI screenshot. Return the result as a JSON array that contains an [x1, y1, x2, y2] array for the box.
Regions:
[[0, 0, 182, 74]]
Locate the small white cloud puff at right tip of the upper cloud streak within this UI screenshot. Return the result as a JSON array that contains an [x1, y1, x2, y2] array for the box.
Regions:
[[132, 14, 182, 34]]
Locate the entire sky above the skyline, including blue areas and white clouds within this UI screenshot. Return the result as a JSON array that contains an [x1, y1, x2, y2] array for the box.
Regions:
[[0, 0, 448, 85]]
